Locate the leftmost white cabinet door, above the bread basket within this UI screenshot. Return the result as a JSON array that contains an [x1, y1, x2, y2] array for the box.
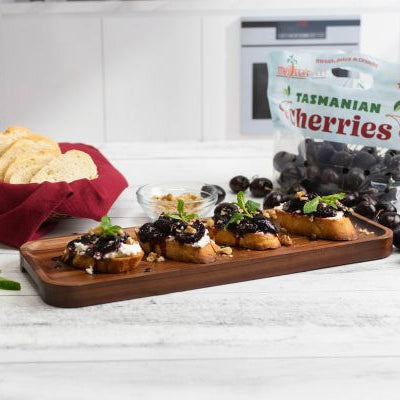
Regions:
[[0, 15, 104, 142]]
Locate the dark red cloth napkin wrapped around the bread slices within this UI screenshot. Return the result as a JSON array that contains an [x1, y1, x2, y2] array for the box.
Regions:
[[0, 143, 128, 247]]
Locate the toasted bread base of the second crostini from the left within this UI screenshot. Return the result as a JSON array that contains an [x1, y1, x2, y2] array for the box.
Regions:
[[137, 235, 217, 264]]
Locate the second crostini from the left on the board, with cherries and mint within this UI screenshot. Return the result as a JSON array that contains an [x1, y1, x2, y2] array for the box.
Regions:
[[138, 200, 216, 264]]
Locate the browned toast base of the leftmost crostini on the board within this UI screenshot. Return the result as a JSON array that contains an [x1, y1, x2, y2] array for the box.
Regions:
[[61, 249, 144, 274]]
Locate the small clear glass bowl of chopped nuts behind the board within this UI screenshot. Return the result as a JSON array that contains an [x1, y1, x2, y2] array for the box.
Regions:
[[136, 182, 218, 221]]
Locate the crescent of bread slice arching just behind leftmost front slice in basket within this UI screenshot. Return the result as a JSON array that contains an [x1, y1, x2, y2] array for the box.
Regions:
[[0, 139, 60, 180]]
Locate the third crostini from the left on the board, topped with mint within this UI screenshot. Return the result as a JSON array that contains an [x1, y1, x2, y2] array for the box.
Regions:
[[207, 192, 281, 250]]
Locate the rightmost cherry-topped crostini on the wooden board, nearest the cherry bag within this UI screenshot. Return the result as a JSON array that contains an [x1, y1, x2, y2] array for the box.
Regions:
[[274, 192, 357, 240]]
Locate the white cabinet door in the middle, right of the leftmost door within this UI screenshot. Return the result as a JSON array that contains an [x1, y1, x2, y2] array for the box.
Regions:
[[103, 15, 202, 141]]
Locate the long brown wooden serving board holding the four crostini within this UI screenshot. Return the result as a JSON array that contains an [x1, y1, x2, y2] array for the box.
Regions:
[[21, 215, 392, 307]]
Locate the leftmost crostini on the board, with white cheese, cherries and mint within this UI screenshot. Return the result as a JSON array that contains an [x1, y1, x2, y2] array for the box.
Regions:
[[61, 216, 144, 274]]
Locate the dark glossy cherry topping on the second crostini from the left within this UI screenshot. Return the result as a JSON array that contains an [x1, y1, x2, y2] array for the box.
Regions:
[[139, 215, 206, 244]]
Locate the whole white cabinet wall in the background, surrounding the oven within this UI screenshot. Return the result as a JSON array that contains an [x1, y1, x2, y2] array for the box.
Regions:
[[0, 0, 400, 143]]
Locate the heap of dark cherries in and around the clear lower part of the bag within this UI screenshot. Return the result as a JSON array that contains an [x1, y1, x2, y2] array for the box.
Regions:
[[264, 139, 400, 248]]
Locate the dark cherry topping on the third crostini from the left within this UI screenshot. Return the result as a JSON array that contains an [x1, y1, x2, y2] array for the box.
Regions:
[[213, 203, 278, 236]]
